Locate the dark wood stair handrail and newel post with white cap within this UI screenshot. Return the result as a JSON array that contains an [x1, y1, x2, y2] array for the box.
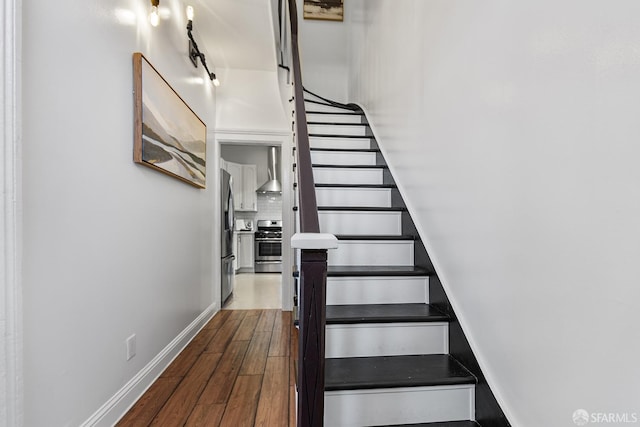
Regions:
[[280, 0, 338, 427]]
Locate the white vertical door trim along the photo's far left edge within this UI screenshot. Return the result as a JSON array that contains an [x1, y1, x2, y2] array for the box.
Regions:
[[0, 0, 23, 427]]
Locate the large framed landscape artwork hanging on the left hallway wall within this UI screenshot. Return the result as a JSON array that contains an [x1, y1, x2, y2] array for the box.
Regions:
[[133, 53, 207, 188]]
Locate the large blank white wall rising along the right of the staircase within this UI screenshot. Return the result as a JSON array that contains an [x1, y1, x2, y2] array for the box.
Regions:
[[349, 0, 640, 427]]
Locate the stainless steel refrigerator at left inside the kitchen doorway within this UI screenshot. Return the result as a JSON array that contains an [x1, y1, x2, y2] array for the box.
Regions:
[[220, 170, 236, 305]]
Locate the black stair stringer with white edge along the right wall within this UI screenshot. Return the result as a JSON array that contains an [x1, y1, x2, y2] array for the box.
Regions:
[[350, 103, 511, 427]]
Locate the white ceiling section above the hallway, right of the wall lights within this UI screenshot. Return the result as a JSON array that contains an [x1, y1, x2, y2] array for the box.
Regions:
[[187, 0, 277, 71]]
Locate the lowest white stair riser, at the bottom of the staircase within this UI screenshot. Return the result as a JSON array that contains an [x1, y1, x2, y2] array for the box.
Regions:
[[324, 385, 475, 427]]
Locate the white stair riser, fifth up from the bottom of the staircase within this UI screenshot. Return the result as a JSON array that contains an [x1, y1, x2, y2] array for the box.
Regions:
[[318, 211, 402, 236]]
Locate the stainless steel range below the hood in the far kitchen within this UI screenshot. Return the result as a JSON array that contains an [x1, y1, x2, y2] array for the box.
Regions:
[[255, 220, 282, 273]]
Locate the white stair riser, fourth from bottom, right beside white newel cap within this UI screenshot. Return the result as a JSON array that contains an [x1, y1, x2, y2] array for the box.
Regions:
[[329, 240, 414, 266]]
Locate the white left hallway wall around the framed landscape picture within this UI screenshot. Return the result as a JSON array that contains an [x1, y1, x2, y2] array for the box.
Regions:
[[22, 0, 219, 426]]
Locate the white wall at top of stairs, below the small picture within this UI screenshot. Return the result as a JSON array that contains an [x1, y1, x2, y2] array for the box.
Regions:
[[296, 0, 351, 102]]
